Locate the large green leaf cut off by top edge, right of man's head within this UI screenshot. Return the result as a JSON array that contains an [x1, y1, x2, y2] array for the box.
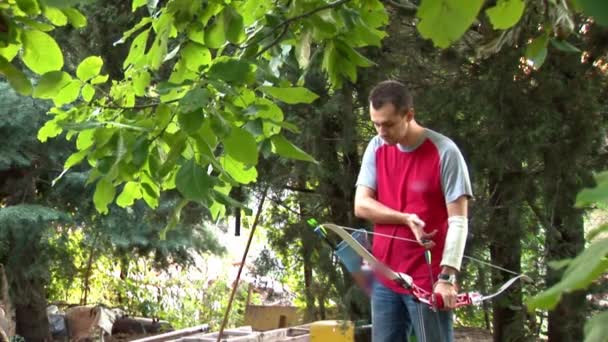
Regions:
[[416, 0, 484, 48]]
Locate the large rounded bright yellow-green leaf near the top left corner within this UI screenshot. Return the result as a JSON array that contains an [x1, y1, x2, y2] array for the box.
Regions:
[[21, 30, 63, 75]]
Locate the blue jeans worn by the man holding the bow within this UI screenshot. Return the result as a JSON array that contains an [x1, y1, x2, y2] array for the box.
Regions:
[[372, 281, 454, 342]]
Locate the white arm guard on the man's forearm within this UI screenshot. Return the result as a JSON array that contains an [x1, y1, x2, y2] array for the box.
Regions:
[[441, 216, 469, 271]]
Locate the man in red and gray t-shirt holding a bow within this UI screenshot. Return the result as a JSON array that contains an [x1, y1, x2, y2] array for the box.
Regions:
[[355, 81, 472, 342]]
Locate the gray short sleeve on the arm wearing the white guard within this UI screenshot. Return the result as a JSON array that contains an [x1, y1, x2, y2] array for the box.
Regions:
[[441, 141, 473, 203]]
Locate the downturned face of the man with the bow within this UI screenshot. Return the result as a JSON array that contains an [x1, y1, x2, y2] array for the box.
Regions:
[[369, 103, 411, 145]]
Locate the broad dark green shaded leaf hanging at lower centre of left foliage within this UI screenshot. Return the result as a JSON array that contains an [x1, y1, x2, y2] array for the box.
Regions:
[[175, 159, 215, 204]]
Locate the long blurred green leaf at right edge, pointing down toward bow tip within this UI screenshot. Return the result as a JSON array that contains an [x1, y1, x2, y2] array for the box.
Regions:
[[526, 239, 608, 311]]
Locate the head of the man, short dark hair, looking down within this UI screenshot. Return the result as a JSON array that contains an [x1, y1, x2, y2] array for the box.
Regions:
[[369, 81, 414, 144]]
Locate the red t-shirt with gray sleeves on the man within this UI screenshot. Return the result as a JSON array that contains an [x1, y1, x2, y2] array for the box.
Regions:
[[357, 129, 472, 293]]
